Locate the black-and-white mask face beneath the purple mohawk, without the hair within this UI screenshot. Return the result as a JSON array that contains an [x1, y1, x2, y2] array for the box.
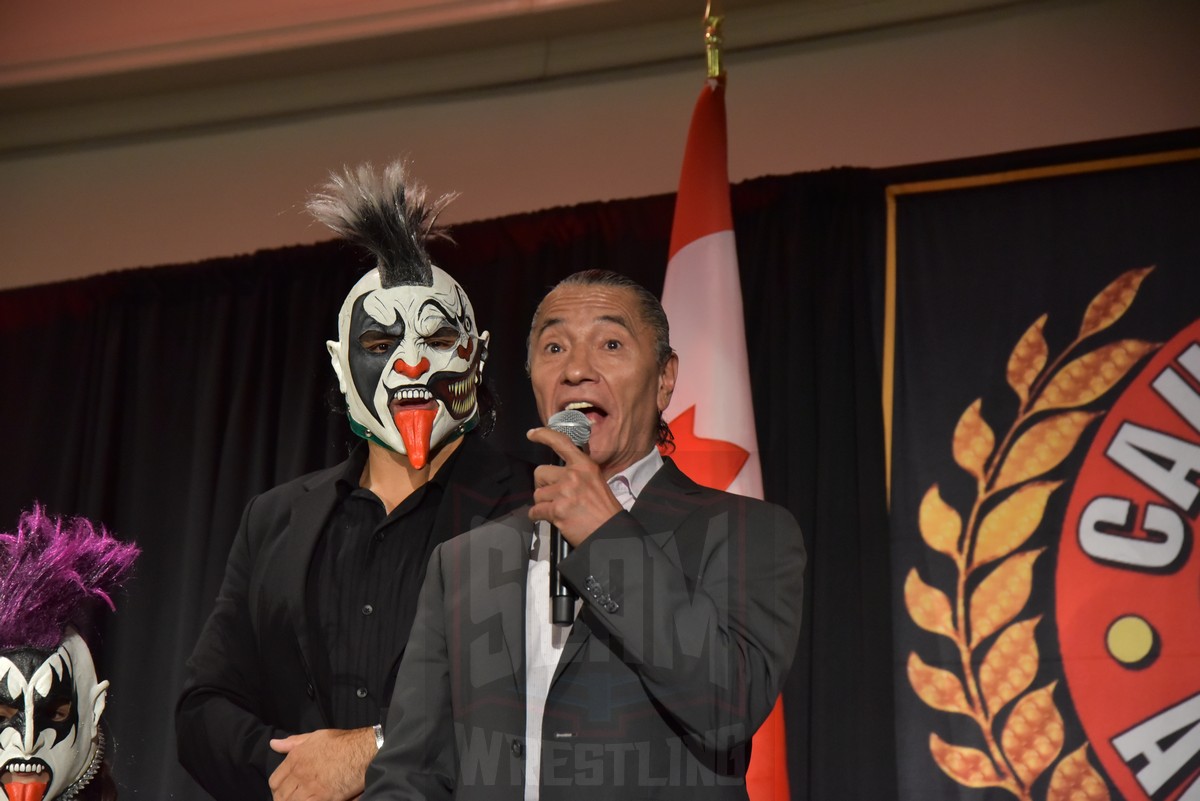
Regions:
[[0, 628, 108, 801]]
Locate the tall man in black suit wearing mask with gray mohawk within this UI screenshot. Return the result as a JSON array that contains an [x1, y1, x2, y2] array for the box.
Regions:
[[175, 164, 532, 801]]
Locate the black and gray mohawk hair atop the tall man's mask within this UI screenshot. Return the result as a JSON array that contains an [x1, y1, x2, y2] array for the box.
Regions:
[[306, 161, 458, 288]]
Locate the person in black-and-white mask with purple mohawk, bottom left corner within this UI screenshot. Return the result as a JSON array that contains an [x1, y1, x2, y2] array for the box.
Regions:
[[0, 505, 139, 801]]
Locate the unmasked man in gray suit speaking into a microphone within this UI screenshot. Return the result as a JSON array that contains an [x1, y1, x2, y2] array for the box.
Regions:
[[364, 271, 804, 801]]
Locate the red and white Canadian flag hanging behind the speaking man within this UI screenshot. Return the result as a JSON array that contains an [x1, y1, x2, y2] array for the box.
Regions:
[[662, 77, 790, 801]]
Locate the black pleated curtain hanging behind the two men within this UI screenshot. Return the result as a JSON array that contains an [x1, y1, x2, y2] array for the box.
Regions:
[[0, 169, 895, 800]]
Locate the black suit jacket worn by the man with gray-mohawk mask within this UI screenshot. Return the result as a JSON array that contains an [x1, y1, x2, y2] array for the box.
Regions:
[[175, 435, 532, 801]]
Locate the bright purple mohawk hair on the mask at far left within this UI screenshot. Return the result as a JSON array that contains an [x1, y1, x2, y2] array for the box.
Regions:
[[0, 504, 140, 651]]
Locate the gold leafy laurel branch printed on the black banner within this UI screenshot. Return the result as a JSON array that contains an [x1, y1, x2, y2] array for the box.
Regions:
[[904, 267, 1158, 801]]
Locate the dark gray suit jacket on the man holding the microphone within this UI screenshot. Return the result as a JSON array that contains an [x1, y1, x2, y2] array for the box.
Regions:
[[364, 459, 805, 801]]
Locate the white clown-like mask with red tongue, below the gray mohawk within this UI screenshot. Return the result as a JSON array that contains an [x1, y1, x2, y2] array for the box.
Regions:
[[326, 267, 488, 469]]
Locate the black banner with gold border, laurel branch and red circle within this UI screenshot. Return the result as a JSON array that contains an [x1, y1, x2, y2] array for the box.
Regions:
[[886, 151, 1200, 801]]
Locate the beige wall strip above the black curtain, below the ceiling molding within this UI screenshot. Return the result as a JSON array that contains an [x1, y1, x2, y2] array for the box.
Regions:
[[0, 0, 1200, 287]]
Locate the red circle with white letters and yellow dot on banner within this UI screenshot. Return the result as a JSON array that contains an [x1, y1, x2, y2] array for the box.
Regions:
[[1055, 320, 1200, 801]]
